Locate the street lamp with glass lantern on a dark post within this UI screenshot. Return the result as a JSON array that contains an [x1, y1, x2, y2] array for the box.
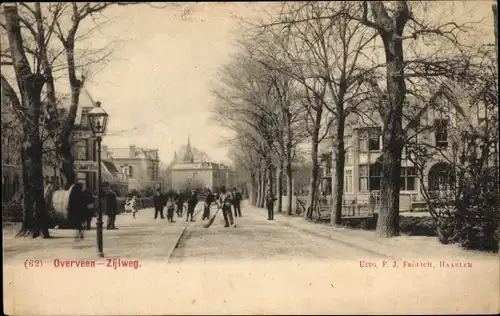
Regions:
[[88, 102, 109, 257]]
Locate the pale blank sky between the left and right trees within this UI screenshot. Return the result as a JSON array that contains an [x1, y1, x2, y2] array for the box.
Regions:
[[79, 3, 262, 163]]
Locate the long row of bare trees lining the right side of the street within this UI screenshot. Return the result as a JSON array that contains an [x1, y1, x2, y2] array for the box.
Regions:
[[215, 1, 498, 244]]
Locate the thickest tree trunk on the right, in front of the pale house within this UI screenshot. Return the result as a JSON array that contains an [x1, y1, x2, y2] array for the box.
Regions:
[[377, 28, 406, 237]]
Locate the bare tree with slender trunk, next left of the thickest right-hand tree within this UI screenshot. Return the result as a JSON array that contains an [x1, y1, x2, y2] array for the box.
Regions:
[[248, 2, 380, 224]]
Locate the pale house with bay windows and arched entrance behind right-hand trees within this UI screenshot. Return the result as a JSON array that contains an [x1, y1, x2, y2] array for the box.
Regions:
[[320, 85, 486, 211]]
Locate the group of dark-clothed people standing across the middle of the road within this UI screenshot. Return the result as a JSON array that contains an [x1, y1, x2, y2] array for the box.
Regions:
[[153, 186, 243, 227]]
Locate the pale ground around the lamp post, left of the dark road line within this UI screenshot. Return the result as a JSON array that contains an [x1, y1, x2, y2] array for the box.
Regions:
[[2, 209, 199, 263]]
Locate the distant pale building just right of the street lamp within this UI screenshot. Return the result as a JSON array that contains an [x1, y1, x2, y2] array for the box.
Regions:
[[102, 145, 162, 191]]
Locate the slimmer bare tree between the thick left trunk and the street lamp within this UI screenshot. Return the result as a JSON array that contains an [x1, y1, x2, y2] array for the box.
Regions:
[[3, 2, 176, 188]]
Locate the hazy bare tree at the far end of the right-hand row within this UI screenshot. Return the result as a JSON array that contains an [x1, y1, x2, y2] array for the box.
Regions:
[[214, 54, 293, 209]]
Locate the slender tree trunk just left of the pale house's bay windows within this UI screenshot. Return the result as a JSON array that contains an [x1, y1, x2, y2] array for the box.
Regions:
[[330, 116, 345, 225]]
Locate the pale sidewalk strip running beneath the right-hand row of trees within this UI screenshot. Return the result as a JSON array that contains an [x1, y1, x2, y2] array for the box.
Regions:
[[244, 201, 498, 262]]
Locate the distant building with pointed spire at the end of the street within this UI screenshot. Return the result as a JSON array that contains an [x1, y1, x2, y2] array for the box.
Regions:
[[170, 137, 235, 189]]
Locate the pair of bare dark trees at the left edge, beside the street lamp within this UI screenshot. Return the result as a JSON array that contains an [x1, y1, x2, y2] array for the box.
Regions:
[[1, 2, 169, 237]]
